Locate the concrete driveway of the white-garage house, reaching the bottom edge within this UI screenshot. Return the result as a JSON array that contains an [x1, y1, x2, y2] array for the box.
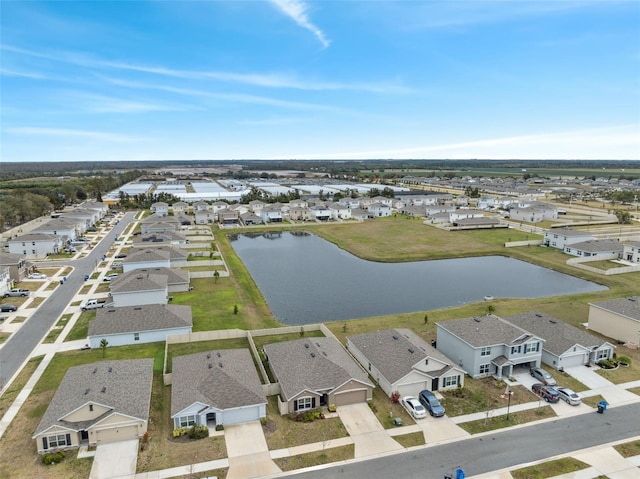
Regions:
[[224, 421, 282, 479]]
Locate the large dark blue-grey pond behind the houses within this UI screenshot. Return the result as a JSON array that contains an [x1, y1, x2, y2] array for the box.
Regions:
[[231, 232, 607, 326]]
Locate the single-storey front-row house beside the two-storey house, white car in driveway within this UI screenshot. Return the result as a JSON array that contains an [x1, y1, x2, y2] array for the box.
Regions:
[[347, 329, 465, 396]]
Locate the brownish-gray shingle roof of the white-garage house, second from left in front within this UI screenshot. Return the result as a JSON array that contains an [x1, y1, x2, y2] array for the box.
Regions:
[[171, 349, 267, 415]]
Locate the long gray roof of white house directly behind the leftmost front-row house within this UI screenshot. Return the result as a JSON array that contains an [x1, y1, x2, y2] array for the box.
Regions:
[[88, 304, 193, 336]]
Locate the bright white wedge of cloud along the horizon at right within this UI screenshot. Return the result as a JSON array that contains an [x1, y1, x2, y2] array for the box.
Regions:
[[288, 125, 640, 159]]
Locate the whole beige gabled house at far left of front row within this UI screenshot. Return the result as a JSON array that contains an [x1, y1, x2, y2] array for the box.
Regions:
[[33, 358, 153, 454]]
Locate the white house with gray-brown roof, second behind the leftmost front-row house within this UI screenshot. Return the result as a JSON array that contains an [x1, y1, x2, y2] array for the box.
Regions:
[[109, 269, 169, 308]]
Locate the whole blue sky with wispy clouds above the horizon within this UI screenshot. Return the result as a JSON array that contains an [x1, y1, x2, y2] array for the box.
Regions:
[[0, 0, 640, 161]]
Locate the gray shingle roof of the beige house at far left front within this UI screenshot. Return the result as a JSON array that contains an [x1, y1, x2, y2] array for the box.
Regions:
[[34, 359, 153, 436]]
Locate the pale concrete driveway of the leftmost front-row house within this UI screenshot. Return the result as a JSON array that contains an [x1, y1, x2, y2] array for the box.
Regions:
[[89, 439, 138, 479]]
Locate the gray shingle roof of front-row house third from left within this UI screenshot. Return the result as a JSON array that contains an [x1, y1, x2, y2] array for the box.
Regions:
[[264, 338, 373, 400]]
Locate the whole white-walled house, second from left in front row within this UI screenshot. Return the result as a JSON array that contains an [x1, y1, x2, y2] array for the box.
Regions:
[[171, 349, 267, 429]]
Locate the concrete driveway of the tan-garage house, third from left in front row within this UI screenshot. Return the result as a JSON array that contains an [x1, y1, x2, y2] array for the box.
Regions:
[[338, 403, 404, 457]]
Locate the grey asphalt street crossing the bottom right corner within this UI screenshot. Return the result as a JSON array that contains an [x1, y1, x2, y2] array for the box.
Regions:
[[290, 403, 640, 479]]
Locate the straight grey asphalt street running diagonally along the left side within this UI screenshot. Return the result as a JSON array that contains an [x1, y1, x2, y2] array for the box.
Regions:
[[0, 213, 135, 390]]
